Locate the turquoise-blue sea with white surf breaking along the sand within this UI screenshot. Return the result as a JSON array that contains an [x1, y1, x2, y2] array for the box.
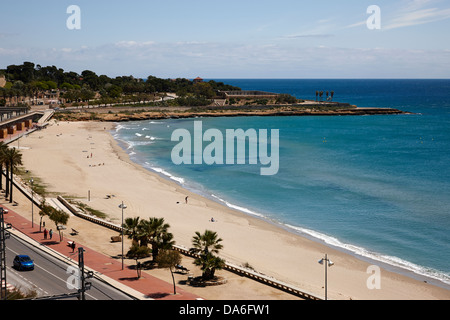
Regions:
[[113, 79, 450, 285]]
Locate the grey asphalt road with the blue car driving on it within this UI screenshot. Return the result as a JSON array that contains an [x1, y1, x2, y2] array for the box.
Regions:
[[6, 235, 132, 300]]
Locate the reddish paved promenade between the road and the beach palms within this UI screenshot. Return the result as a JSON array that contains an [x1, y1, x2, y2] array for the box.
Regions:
[[4, 207, 200, 300]]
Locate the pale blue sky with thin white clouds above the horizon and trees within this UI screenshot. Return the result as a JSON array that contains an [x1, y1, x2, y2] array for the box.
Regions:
[[0, 0, 450, 79]]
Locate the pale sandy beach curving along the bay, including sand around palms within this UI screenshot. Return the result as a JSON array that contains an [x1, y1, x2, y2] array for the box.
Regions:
[[13, 121, 450, 300]]
